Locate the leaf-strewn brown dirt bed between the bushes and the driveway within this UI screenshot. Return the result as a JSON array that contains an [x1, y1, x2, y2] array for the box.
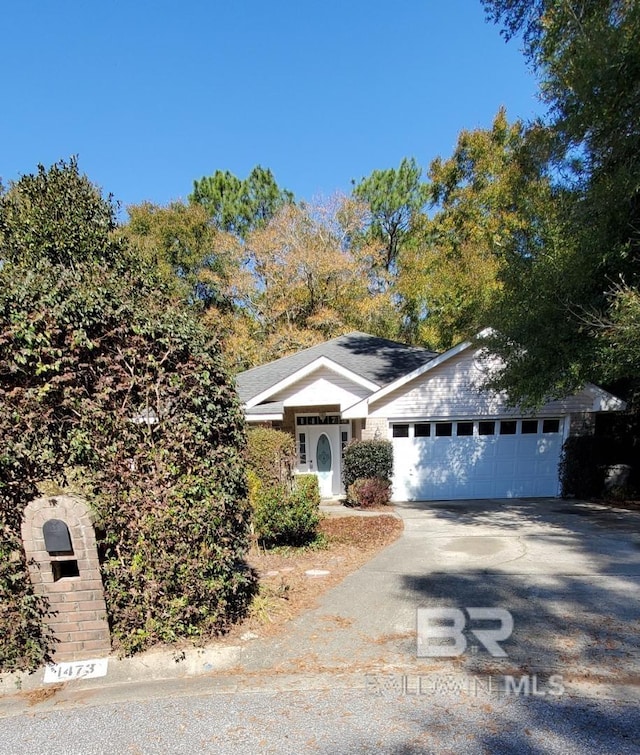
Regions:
[[225, 514, 402, 643]]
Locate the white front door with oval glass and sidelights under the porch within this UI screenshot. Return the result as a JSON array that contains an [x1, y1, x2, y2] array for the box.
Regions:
[[296, 415, 351, 498]]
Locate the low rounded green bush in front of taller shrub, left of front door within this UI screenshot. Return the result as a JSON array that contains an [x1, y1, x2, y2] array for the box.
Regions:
[[253, 475, 320, 547]]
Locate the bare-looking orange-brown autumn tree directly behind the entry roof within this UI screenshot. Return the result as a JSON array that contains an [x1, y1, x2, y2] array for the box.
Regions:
[[235, 197, 397, 361]]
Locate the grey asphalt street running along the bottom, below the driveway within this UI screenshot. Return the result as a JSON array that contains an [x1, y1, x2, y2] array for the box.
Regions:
[[0, 675, 640, 755]]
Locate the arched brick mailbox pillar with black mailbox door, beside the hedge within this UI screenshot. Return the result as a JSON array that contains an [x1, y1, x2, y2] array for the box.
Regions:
[[22, 495, 111, 661]]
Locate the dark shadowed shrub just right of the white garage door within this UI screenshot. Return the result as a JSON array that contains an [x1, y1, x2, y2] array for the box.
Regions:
[[560, 435, 605, 498]]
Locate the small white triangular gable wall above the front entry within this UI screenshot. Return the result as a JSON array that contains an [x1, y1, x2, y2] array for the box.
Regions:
[[270, 367, 371, 411]]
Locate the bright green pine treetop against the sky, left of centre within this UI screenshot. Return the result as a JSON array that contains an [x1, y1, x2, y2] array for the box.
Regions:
[[189, 165, 294, 238]]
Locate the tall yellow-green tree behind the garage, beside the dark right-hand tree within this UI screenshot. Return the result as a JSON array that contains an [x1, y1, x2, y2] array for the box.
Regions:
[[397, 110, 552, 350]]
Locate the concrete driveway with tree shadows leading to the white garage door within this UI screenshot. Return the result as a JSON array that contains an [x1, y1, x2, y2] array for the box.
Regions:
[[242, 499, 640, 695]]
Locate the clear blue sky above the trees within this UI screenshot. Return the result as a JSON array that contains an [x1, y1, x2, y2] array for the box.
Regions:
[[0, 0, 543, 213]]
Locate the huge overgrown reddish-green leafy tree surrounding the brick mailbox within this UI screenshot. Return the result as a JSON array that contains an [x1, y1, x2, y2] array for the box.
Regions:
[[0, 160, 253, 669]]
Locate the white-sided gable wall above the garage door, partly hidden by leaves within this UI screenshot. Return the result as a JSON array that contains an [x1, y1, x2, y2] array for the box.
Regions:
[[367, 349, 593, 427]]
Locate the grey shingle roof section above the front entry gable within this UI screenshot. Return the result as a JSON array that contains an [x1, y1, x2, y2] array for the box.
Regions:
[[236, 331, 437, 403]]
